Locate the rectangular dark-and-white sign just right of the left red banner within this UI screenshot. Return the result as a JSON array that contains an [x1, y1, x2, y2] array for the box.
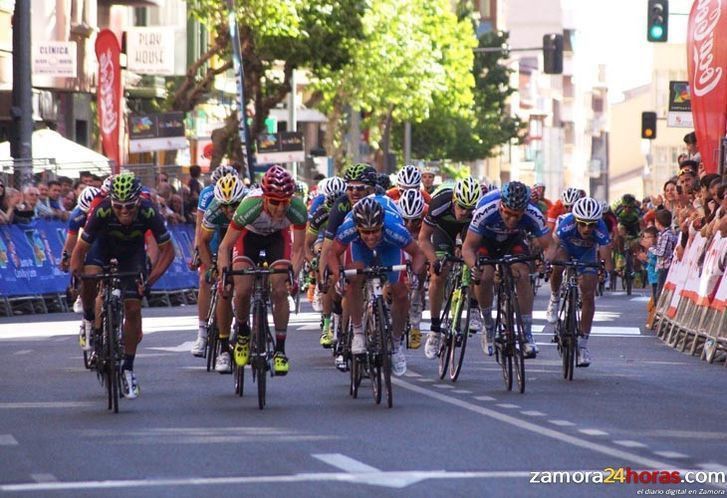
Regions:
[[129, 112, 188, 152]]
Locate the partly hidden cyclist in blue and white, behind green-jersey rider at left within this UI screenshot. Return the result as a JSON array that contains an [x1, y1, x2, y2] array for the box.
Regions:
[[192, 166, 238, 356]]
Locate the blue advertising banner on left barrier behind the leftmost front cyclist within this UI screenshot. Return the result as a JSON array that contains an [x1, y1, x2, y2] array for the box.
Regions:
[[0, 220, 198, 297]]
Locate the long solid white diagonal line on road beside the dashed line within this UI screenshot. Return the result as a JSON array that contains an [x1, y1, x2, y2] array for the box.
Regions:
[[392, 379, 692, 469]]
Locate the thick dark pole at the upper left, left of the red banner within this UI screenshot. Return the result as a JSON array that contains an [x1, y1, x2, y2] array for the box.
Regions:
[[10, 0, 33, 187]]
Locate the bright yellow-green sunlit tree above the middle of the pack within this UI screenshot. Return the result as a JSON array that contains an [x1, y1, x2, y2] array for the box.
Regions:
[[315, 0, 476, 171]]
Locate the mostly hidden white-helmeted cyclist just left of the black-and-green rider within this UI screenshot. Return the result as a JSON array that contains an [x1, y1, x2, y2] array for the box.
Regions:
[[397, 189, 427, 349]]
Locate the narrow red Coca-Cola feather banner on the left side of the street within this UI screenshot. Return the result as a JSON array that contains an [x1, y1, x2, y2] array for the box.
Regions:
[[96, 29, 121, 173]]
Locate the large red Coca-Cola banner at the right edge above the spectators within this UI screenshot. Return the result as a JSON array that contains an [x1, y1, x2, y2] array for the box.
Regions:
[[687, 0, 727, 173]]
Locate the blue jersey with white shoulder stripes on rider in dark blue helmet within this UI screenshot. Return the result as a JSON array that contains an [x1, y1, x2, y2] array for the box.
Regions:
[[469, 191, 550, 242]]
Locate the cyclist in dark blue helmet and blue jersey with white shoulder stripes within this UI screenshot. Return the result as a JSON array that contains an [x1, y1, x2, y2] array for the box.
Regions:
[[462, 181, 553, 358]]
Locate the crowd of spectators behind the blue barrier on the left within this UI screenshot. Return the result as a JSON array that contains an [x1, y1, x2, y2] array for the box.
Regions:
[[0, 166, 204, 225]]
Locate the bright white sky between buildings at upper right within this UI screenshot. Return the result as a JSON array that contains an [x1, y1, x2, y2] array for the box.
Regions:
[[563, 0, 692, 99]]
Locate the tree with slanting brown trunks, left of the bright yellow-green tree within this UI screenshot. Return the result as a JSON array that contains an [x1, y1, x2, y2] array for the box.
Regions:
[[171, 0, 366, 171]]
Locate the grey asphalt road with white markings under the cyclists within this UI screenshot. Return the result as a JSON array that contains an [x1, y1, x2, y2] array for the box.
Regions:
[[0, 286, 727, 497]]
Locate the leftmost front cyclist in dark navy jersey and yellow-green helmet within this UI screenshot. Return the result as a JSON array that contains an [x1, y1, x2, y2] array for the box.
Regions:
[[71, 172, 174, 399]]
